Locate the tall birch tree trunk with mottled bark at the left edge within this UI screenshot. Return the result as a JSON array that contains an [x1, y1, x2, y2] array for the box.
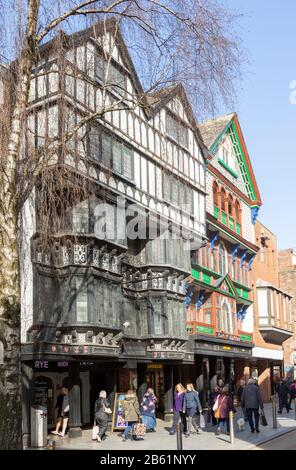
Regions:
[[0, 0, 39, 449]]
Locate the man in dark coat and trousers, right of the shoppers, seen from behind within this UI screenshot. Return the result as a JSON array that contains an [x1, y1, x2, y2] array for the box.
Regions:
[[241, 379, 264, 433]]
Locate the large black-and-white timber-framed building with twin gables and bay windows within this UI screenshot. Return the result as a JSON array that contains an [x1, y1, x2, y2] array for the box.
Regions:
[[21, 21, 207, 444]]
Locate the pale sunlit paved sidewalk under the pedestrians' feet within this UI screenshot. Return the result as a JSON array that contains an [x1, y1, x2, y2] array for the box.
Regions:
[[49, 404, 296, 451]]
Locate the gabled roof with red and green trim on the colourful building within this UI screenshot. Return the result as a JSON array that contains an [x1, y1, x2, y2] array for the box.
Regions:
[[198, 113, 262, 207]]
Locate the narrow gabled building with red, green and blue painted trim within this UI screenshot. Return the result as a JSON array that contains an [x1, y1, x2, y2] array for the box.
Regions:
[[186, 114, 261, 399]]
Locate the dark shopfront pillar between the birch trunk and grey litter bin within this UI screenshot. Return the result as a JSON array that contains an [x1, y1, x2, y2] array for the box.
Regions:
[[21, 363, 34, 448]]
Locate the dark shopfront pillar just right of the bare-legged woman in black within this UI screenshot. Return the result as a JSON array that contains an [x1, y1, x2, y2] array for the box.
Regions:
[[68, 362, 82, 437]]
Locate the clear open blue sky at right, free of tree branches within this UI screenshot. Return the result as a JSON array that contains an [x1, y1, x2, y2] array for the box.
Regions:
[[222, 0, 296, 249]]
